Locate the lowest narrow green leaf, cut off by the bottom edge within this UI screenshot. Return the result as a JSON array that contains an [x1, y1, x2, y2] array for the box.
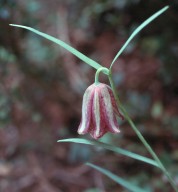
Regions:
[[86, 163, 146, 192]]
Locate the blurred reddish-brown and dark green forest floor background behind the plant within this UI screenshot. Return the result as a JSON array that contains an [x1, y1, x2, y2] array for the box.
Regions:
[[0, 0, 178, 192]]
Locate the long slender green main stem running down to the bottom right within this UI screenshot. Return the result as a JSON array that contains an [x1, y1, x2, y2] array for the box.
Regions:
[[108, 70, 178, 192]]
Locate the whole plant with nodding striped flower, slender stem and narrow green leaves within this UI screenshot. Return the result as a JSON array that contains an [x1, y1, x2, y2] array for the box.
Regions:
[[10, 5, 178, 192]]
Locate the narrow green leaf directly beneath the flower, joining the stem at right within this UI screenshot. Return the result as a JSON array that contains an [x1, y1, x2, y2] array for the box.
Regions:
[[58, 138, 159, 167]]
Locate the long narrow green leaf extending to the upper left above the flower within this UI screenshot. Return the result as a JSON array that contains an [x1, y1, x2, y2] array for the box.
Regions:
[[10, 24, 102, 69]]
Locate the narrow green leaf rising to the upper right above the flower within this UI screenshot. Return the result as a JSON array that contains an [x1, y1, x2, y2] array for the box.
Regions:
[[110, 6, 169, 68]]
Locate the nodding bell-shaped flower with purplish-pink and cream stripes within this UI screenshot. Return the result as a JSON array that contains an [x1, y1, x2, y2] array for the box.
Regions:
[[78, 83, 123, 139]]
